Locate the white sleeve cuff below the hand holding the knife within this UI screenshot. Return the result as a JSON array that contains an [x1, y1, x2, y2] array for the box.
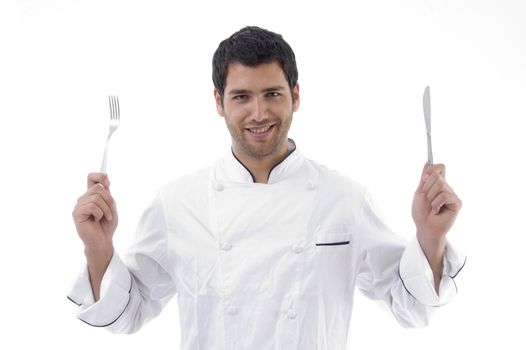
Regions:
[[399, 237, 466, 306]]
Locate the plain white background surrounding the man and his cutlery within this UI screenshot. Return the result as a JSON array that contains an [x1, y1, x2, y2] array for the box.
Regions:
[[0, 0, 526, 350]]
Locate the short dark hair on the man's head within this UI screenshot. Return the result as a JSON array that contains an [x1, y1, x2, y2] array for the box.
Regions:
[[212, 26, 298, 96]]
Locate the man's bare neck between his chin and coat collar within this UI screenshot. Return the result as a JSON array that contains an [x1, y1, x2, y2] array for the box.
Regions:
[[232, 140, 289, 184]]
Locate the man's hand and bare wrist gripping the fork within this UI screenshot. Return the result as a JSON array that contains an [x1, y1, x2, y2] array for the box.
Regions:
[[73, 173, 119, 300]]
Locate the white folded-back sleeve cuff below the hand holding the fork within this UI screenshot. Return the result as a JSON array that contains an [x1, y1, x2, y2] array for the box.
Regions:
[[68, 252, 132, 327]]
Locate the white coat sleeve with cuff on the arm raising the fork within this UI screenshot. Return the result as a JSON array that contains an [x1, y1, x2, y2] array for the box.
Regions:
[[68, 196, 177, 333]]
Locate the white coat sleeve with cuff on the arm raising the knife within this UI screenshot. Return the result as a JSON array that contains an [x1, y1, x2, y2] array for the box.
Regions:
[[357, 193, 466, 327]]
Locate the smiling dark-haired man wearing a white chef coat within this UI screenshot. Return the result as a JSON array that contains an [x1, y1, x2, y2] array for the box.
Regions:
[[69, 27, 465, 350]]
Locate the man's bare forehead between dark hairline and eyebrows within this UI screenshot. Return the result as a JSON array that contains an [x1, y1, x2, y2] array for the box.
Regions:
[[225, 61, 288, 91]]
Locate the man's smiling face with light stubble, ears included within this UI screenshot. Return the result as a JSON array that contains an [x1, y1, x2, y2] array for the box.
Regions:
[[214, 62, 299, 158]]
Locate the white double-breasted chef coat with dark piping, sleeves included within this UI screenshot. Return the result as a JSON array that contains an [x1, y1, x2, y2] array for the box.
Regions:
[[68, 140, 465, 350]]
